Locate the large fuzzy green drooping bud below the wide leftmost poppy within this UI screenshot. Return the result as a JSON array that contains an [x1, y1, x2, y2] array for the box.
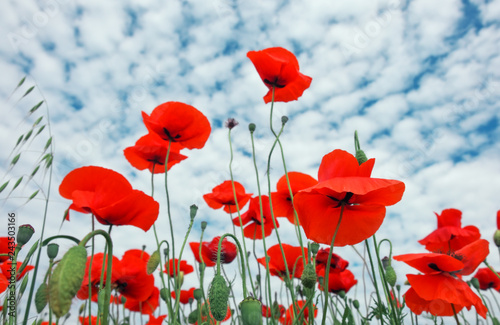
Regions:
[[49, 246, 87, 318]]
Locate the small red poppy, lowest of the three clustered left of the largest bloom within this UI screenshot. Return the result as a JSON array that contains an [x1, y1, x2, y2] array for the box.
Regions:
[[233, 195, 279, 239]]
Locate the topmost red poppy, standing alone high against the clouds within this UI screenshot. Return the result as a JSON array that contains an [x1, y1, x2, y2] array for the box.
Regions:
[[247, 47, 312, 104]]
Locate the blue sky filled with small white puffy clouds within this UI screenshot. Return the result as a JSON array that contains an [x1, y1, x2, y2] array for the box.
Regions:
[[0, 0, 500, 322]]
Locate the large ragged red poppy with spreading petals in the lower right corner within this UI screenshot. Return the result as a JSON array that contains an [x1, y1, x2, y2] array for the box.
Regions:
[[394, 239, 489, 318]]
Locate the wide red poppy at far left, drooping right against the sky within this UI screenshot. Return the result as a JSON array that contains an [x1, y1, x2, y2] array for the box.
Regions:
[[59, 166, 160, 231]]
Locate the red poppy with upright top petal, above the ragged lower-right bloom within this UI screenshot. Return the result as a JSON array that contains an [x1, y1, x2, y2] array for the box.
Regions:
[[418, 209, 481, 253]]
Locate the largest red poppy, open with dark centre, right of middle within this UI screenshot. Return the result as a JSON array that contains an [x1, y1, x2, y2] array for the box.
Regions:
[[294, 150, 405, 246]]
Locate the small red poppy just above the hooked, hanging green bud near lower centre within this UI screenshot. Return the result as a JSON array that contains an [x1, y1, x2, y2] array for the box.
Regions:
[[189, 236, 238, 266]]
